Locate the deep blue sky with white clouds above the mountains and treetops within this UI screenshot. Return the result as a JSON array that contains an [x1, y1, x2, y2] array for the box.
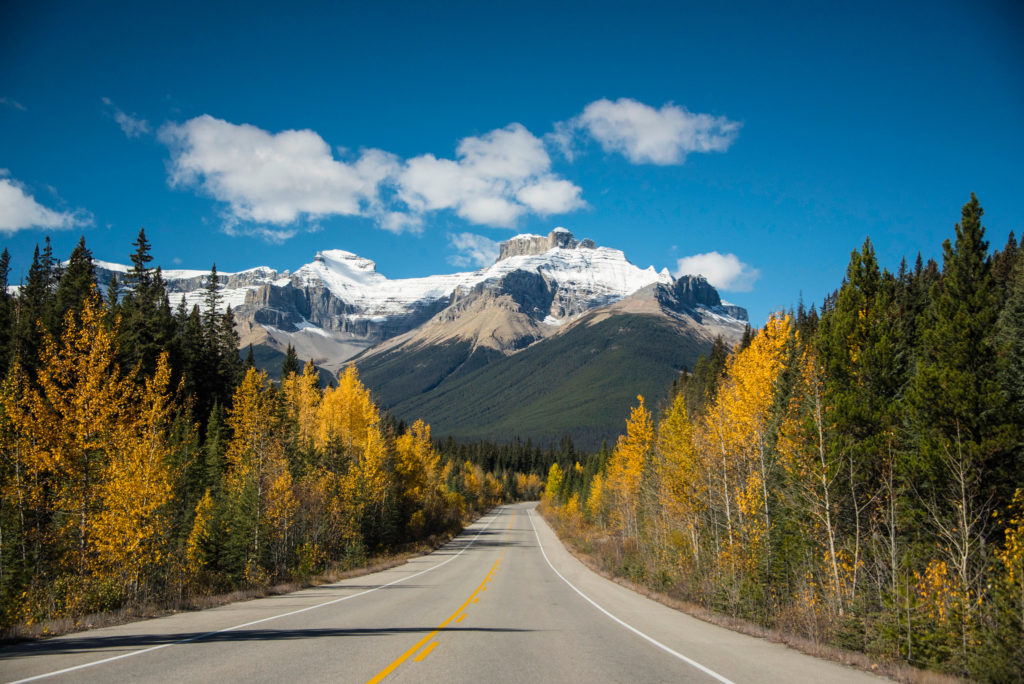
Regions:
[[0, 0, 1024, 324]]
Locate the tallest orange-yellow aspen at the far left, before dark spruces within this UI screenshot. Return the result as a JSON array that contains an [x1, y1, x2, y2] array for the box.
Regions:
[[23, 292, 135, 575]]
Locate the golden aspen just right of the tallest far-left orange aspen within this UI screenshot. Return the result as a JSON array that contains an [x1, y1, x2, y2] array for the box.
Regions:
[[90, 352, 175, 594]]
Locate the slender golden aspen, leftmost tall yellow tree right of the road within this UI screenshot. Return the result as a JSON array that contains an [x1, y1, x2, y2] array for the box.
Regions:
[[607, 396, 654, 539]]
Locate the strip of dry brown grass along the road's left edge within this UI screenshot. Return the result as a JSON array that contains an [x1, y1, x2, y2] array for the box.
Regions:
[[0, 535, 462, 645]]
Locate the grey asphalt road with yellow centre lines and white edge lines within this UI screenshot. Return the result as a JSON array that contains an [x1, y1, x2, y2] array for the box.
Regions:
[[0, 504, 880, 684]]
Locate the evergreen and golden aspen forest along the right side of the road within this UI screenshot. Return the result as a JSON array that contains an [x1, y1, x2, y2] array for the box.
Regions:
[[544, 196, 1024, 681]]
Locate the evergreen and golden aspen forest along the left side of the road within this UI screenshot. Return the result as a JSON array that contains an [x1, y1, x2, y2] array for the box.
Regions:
[[0, 231, 543, 630]]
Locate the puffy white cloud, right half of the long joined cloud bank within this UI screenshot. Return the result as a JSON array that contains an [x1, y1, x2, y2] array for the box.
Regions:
[[397, 124, 586, 227]]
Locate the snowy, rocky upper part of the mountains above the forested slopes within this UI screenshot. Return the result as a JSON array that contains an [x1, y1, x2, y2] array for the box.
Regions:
[[96, 227, 745, 371]]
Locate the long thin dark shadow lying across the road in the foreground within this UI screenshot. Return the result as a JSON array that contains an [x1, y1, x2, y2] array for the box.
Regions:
[[0, 627, 532, 661]]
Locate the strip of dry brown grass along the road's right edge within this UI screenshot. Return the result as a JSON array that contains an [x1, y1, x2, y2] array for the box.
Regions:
[[542, 510, 969, 684]]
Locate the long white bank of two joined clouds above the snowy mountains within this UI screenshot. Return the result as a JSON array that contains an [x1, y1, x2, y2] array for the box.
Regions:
[[159, 115, 586, 241]]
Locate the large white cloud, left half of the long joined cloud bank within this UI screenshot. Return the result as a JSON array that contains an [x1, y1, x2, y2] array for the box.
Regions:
[[160, 115, 398, 225]]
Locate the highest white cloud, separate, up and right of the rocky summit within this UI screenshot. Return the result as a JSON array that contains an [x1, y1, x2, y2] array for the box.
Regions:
[[565, 97, 740, 166]]
